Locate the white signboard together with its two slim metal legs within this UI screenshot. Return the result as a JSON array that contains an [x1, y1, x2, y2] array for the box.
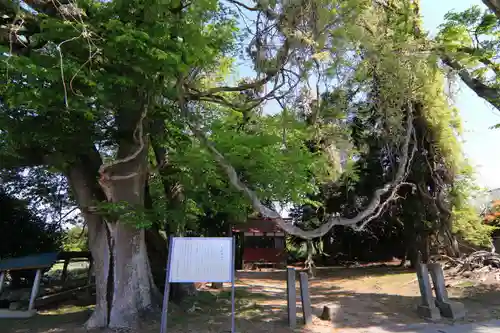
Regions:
[[160, 237, 236, 333]]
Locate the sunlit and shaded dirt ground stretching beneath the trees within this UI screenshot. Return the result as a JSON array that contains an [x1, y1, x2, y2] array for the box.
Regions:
[[0, 266, 500, 333]]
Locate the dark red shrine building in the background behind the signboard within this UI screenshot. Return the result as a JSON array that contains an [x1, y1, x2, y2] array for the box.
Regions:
[[232, 217, 288, 269]]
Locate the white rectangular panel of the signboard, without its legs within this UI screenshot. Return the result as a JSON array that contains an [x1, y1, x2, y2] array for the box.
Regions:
[[169, 237, 234, 283]]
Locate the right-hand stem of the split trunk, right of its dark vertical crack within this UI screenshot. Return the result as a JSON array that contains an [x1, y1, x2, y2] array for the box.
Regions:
[[100, 138, 160, 328]]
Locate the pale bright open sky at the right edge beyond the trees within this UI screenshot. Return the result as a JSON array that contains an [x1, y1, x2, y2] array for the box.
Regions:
[[420, 0, 500, 189]]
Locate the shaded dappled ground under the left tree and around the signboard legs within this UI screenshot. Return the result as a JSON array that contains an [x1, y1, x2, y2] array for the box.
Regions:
[[0, 288, 292, 333]]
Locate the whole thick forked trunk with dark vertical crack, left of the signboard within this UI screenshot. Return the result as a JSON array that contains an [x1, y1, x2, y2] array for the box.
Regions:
[[67, 129, 161, 328]]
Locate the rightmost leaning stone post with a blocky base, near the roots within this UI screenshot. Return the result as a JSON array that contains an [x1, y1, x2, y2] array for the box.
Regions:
[[428, 263, 465, 319]]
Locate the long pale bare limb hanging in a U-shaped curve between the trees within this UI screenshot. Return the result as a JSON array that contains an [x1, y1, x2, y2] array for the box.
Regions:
[[178, 85, 414, 239]]
